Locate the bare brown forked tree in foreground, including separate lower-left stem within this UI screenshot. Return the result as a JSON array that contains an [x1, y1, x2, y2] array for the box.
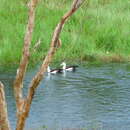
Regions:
[[0, 0, 83, 130]]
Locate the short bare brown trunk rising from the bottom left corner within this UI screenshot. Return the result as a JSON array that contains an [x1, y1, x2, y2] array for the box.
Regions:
[[0, 82, 11, 130]]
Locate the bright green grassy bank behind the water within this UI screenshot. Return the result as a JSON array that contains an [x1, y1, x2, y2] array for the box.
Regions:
[[0, 0, 130, 64]]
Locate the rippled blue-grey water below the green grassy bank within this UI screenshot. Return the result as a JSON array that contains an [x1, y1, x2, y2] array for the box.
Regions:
[[0, 63, 130, 130]]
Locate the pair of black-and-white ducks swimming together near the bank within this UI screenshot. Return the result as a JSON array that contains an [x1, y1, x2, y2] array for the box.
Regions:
[[47, 62, 78, 74]]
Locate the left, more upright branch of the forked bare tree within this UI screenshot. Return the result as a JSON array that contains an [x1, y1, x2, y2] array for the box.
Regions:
[[14, 0, 37, 116]]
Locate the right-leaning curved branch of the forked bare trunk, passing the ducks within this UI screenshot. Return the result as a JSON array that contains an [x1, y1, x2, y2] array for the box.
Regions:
[[25, 0, 82, 121]]
